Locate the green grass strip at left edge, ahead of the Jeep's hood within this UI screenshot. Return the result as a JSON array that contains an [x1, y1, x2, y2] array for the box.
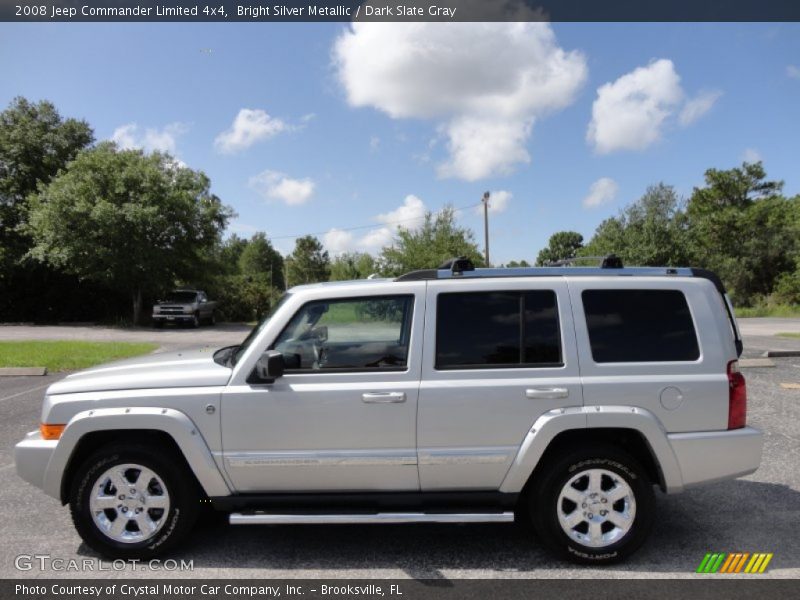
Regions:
[[0, 341, 158, 371]]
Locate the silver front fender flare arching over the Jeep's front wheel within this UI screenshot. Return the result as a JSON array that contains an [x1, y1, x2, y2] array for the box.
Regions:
[[44, 407, 231, 498]]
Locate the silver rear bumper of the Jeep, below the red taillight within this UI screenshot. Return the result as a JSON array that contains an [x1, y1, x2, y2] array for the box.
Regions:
[[668, 427, 764, 487]]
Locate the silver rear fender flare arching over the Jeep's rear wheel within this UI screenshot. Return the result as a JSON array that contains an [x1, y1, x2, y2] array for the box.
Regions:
[[500, 406, 684, 493]]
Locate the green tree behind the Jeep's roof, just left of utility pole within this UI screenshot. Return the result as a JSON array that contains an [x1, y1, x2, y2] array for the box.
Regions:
[[380, 206, 483, 276]]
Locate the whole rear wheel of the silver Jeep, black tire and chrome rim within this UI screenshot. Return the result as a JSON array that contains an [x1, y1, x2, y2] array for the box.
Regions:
[[528, 444, 655, 565]]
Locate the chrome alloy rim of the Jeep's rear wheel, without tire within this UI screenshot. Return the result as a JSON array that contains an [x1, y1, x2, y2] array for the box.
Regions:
[[556, 469, 636, 548]]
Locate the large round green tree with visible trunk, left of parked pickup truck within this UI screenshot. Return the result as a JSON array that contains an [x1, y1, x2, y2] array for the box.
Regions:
[[26, 142, 232, 323]]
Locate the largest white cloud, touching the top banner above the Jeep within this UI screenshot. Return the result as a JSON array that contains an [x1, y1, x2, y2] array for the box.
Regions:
[[333, 22, 587, 181]]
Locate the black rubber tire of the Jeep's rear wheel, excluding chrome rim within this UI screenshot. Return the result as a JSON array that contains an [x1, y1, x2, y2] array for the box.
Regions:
[[524, 444, 655, 566]]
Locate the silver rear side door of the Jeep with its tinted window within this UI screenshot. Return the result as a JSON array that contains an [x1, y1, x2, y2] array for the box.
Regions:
[[417, 277, 582, 490]]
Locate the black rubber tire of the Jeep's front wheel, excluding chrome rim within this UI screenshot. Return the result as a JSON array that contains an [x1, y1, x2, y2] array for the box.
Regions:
[[69, 443, 200, 560]]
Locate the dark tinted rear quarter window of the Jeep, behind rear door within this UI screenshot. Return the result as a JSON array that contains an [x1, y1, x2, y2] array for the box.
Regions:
[[581, 289, 700, 363]]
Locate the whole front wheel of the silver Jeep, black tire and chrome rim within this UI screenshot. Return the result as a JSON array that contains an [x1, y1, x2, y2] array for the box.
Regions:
[[70, 444, 199, 559]]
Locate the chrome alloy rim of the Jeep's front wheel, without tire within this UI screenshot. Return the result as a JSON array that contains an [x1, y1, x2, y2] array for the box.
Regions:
[[89, 464, 170, 544]]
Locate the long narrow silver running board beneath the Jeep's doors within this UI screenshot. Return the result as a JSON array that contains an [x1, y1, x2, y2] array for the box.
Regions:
[[230, 511, 514, 525]]
